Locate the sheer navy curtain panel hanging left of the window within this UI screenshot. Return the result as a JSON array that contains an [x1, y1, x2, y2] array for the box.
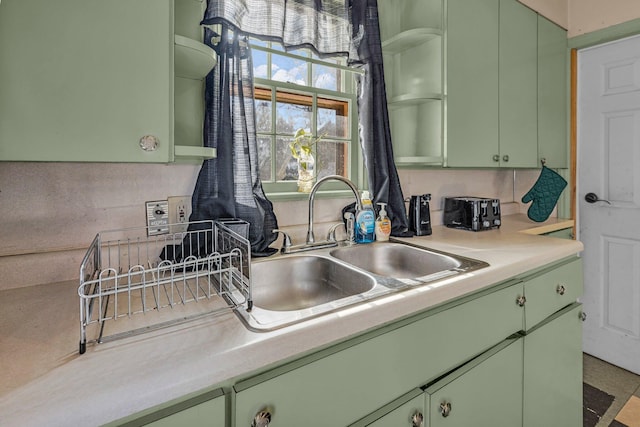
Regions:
[[190, 26, 278, 256]]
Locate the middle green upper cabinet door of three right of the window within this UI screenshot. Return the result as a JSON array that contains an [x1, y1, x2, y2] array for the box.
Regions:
[[496, 0, 539, 168]]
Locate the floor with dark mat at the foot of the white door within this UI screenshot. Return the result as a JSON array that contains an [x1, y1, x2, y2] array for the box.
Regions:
[[583, 354, 640, 427]]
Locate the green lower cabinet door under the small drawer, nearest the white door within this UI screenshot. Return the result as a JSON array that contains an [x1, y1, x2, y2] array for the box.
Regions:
[[523, 303, 582, 427]]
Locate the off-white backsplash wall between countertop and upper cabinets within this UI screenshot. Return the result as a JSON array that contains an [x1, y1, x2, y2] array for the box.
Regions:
[[0, 162, 539, 290]]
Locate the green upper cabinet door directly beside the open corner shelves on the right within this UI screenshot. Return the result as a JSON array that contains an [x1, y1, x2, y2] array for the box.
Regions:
[[445, 0, 499, 167]]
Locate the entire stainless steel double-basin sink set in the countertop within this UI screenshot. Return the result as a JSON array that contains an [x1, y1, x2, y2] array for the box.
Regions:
[[236, 242, 488, 331]]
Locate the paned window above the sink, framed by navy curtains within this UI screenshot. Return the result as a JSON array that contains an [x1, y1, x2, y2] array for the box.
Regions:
[[251, 39, 360, 197]]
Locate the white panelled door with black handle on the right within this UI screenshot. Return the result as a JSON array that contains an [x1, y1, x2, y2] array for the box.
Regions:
[[577, 36, 640, 374]]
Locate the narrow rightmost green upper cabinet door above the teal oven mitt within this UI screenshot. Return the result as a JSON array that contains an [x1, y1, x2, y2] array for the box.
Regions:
[[538, 16, 569, 168]]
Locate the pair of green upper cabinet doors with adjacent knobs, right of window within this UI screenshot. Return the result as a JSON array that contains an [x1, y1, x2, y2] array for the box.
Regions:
[[446, 0, 538, 168]]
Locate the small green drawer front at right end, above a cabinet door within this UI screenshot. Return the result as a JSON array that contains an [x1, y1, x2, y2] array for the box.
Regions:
[[524, 258, 583, 331]]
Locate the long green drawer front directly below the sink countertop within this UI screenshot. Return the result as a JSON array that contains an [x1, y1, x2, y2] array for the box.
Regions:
[[235, 283, 522, 426]]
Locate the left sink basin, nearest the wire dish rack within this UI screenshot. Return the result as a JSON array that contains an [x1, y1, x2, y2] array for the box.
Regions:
[[251, 256, 376, 311]]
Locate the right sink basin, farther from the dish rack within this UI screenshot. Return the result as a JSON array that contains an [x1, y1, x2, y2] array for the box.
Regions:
[[330, 243, 464, 280]]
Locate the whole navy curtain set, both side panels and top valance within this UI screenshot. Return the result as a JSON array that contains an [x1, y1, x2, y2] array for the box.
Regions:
[[191, 0, 408, 249]]
